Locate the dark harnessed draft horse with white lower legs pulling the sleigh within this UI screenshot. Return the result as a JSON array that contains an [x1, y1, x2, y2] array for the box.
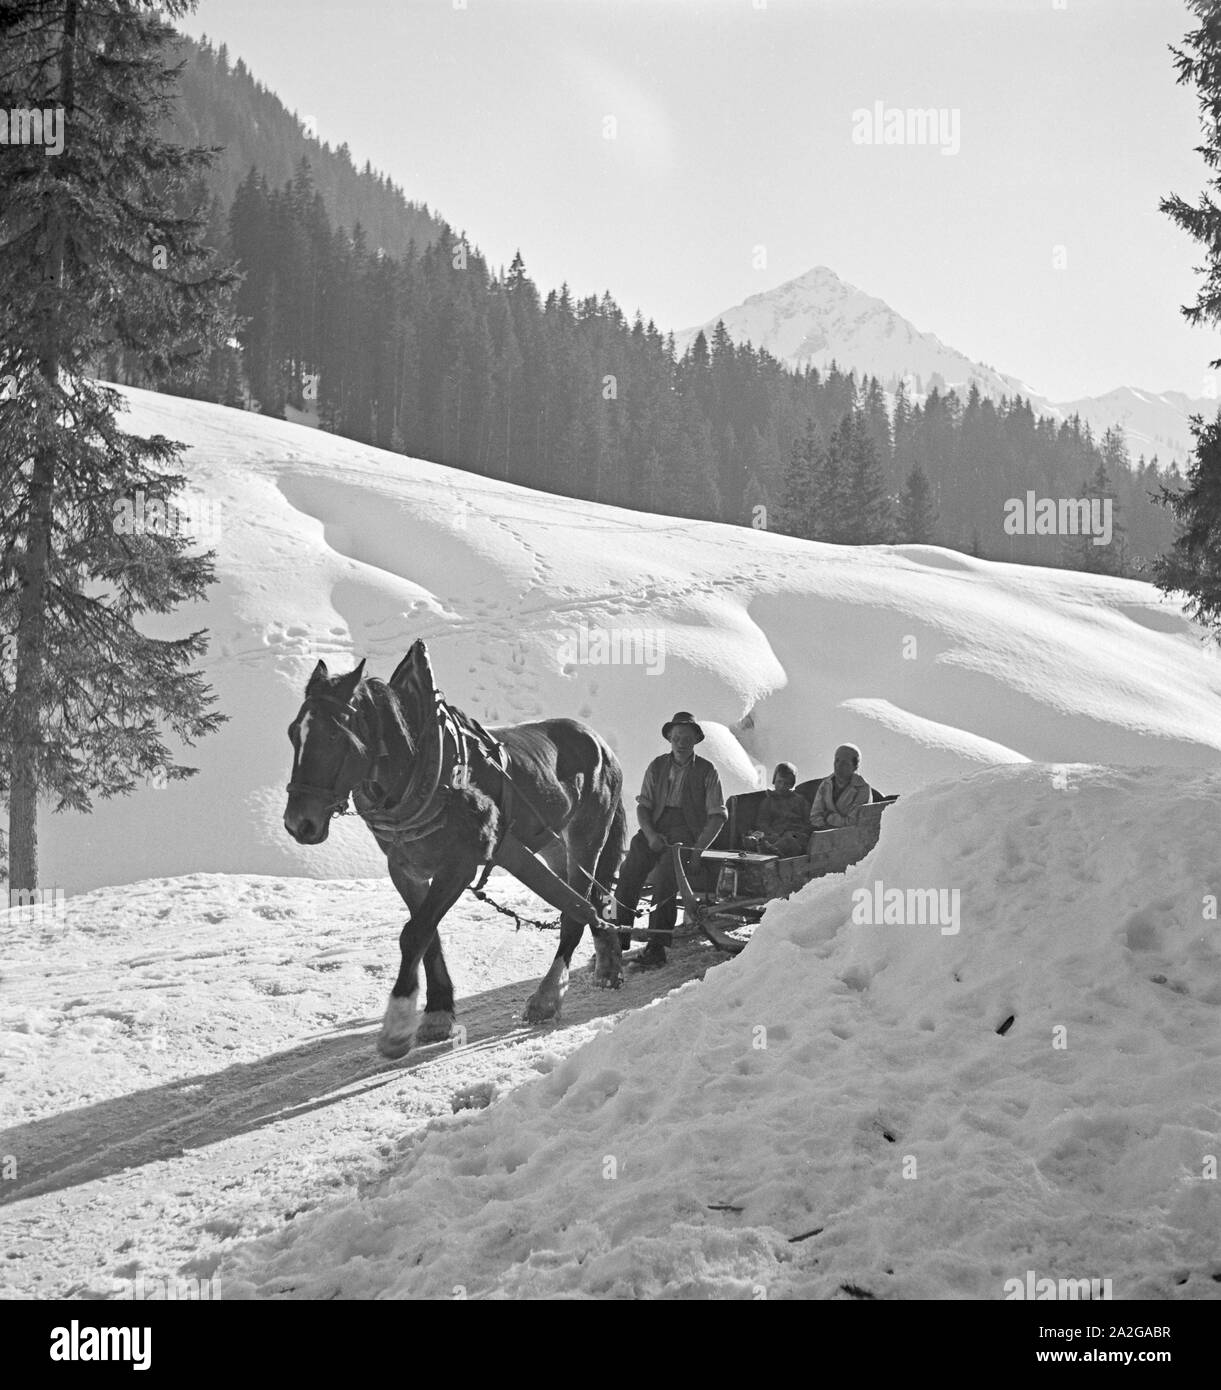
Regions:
[[284, 641, 627, 1059]]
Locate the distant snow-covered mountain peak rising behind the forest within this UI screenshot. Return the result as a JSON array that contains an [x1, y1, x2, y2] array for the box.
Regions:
[[674, 265, 1217, 463]]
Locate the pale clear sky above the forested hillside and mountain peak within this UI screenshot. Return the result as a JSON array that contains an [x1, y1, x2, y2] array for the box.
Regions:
[[184, 0, 1221, 400]]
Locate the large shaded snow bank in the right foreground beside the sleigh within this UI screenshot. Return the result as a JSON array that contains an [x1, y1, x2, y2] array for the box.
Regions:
[[223, 765, 1221, 1298]]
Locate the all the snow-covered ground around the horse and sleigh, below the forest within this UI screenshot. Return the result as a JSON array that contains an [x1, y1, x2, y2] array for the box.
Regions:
[[0, 391, 1221, 1298]]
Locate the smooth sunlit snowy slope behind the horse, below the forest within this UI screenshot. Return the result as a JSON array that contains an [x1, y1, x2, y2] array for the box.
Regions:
[[31, 391, 1221, 894]]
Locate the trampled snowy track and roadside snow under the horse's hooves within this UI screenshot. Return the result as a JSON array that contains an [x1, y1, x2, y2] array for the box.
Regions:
[[0, 872, 719, 1298]]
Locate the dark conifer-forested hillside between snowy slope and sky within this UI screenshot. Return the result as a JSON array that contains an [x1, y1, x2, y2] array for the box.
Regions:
[[136, 43, 1178, 574]]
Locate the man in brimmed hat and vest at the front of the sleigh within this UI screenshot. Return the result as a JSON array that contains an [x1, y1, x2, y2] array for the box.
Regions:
[[615, 709, 727, 970]]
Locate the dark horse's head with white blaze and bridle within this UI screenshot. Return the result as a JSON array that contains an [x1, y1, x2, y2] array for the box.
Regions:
[[284, 662, 373, 845]]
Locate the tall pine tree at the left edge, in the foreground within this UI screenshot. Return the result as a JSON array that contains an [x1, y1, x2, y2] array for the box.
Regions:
[[0, 0, 232, 891]]
